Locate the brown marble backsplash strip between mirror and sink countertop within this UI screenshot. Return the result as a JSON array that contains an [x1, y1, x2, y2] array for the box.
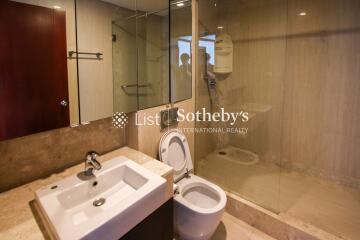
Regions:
[[0, 119, 125, 192]]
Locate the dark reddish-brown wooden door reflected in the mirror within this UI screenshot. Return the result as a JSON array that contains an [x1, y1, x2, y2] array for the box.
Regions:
[[0, 0, 69, 141]]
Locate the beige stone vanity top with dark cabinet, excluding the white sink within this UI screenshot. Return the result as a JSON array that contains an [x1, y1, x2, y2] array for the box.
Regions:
[[0, 147, 173, 240]]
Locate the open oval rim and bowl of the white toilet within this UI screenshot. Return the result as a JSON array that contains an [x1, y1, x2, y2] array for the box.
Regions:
[[175, 174, 226, 214]]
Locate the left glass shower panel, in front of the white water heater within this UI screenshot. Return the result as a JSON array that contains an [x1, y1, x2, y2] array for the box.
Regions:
[[195, 0, 287, 212]]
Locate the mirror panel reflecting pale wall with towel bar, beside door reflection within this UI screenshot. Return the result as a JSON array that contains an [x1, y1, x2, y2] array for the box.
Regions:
[[76, 0, 137, 122]]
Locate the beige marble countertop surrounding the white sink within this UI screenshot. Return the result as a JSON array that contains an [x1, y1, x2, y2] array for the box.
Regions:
[[0, 147, 173, 240]]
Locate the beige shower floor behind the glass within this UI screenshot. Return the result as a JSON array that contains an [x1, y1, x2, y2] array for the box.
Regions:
[[197, 150, 360, 240]]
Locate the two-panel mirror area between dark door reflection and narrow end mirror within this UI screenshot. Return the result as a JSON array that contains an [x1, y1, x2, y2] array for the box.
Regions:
[[76, 0, 170, 117]]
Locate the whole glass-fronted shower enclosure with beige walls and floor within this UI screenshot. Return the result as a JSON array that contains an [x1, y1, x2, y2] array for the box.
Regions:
[[195, 0, 360, 239]]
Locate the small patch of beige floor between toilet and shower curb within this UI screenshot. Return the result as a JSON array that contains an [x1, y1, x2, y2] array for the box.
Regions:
[[211, 212, 274, 240]]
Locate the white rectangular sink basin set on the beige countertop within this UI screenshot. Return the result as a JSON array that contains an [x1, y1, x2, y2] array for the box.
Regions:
[[35, 157, 166, 240]]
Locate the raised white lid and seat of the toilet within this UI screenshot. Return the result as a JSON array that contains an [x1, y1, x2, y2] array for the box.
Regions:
[[159, 129, 193, 182]]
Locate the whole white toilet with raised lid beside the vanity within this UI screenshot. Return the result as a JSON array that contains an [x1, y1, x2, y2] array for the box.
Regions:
[[159, 129, 226, 240]]
